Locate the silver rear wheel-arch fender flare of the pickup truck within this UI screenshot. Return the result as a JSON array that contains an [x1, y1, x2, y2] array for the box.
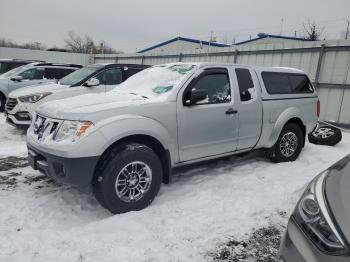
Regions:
[[265, 107, 304, 148]]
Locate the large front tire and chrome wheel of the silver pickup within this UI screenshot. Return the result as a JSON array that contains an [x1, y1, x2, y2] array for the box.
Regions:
[[93, 143, 163, 214]]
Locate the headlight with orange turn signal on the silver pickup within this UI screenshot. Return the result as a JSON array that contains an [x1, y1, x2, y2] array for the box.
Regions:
[[53, 120, 93, 142]]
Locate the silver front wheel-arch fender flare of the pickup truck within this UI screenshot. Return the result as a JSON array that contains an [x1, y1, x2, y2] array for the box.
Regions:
[[96, 115, 177, 164]]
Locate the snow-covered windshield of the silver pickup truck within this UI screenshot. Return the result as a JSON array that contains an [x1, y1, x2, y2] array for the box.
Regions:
[[112, 64, 195, 98]]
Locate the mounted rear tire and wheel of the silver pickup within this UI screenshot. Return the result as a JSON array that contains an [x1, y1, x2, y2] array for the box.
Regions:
[[268, 123, 305, 163]]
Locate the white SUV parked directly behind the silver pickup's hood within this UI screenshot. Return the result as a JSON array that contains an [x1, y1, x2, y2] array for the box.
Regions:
[[5, 64, 148, 128]]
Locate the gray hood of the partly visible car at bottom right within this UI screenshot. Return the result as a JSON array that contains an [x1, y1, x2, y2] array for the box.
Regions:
[[324, 155, 350, 243]]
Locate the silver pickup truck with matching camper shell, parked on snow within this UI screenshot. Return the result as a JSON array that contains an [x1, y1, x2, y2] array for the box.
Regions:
[[27, 63, 320, 213]]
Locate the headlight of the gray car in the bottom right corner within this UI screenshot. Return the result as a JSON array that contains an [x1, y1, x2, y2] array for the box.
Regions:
[[293, 171, 349, 255]]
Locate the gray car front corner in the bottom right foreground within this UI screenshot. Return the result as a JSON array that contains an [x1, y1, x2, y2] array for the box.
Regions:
[[277, 155, 350, 262]]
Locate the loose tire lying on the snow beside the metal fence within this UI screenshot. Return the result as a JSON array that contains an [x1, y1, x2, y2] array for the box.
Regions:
[[308, 125, 342, 146]]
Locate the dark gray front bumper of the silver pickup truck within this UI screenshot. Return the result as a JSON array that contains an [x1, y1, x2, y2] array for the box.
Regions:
[[27, 145, 99, 187]]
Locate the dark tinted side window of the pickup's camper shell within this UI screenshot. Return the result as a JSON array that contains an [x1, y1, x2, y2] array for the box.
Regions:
[[262, 72, 314, 94]]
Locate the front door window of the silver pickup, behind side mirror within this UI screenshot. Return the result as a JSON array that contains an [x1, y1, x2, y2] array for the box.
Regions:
[[192, 73, 231, 105]]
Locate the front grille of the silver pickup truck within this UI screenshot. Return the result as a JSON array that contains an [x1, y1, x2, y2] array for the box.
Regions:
[[33, 115, 60, 141]]
